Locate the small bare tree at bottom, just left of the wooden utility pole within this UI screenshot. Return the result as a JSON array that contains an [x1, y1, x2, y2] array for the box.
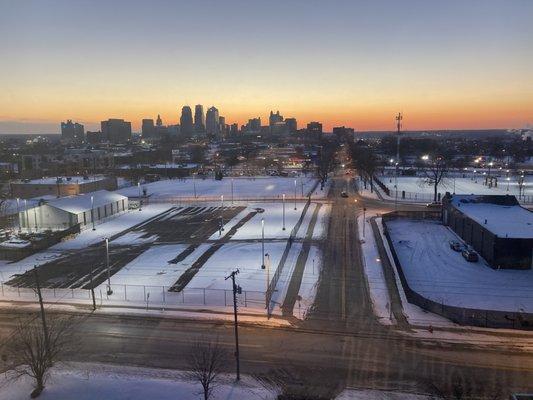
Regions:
[[187, 339, 228, 400]]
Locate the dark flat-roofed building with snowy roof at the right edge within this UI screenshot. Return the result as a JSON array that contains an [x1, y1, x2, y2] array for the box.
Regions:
[[442, 194, 533, 269]]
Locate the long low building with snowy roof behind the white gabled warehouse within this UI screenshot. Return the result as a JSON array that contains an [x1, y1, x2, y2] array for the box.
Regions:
[[11, 175, 117, 199]]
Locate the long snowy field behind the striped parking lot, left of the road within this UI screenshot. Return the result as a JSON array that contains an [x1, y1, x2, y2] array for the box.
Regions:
[[117, 177, 327, 201]]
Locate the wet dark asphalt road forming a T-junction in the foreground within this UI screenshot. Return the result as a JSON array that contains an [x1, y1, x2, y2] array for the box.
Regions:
[[0, 171, 533, 398]]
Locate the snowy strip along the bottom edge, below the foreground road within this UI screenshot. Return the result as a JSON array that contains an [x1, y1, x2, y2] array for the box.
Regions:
[[0, 363, 277, 400]]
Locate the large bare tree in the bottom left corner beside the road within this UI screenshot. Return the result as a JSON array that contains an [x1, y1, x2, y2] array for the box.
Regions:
[[3, 316, 73, 398]]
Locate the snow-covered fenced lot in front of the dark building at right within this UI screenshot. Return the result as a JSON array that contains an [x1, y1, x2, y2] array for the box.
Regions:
[[388, 219, 533, 312]]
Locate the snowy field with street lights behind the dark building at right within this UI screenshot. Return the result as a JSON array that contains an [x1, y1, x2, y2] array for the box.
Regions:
[[379, 176, 533, 200]]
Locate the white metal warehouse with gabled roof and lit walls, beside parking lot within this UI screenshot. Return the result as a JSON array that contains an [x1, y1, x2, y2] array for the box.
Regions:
[[19, 190, 128, 231]]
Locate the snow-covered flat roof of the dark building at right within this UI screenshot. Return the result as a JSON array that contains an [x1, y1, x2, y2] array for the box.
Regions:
[[452, 195, 533, 239]]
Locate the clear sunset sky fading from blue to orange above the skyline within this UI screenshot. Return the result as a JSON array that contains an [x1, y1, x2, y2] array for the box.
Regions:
[[0, 0, 533, 133]]
